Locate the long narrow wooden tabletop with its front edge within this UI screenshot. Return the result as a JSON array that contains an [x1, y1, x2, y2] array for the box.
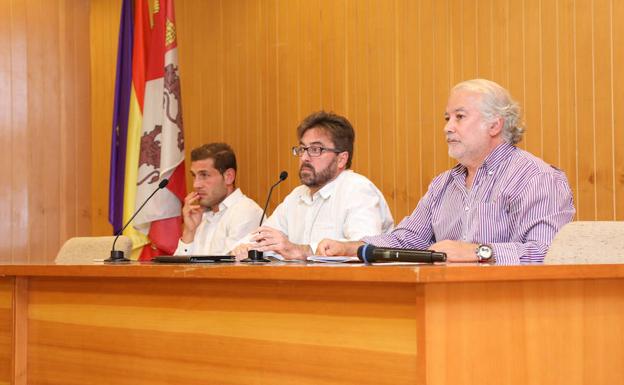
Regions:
[[0, 260, 624, 283]]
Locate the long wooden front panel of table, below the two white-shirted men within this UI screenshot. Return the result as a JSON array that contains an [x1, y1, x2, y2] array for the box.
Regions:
[[27, 278, 424, 385]]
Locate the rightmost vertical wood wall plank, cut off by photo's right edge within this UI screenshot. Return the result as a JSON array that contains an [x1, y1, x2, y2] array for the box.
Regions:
[[609, 1, 624, 220]]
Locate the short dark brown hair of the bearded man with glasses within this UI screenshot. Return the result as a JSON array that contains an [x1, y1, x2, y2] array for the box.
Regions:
[[297, 111, 355, 168]]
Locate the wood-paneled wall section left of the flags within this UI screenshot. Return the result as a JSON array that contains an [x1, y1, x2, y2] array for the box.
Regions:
[[0, 0, 92, 262]]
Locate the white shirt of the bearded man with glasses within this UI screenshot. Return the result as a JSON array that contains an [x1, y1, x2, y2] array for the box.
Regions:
[[264, 170, 394, 252]]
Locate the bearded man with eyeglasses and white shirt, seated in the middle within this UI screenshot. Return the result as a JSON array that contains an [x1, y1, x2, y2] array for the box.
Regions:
[[234, 111, 394, 260]]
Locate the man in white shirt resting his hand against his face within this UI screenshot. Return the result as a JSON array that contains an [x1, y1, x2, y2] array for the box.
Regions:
[[175, 143, 262, 255]]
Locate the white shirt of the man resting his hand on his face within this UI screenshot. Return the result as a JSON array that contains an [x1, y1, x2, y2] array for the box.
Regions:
[[175, 189, 262, 255]]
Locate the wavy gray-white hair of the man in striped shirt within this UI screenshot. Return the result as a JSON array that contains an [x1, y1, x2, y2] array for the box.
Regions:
[[451, 79, 524, 144]]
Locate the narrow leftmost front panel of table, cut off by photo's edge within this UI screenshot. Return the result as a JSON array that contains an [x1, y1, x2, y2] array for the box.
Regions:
[[0, 278, 15, 385]]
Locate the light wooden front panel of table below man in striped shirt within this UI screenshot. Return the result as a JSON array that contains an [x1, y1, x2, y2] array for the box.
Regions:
[[425, 279, 624, 385]]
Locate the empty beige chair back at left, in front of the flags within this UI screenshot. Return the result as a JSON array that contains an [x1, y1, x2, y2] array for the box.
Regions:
[[55, 235, 132, 265]]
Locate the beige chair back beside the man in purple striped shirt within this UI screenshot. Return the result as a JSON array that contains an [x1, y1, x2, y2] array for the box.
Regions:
[[544, 221, 624, 264]]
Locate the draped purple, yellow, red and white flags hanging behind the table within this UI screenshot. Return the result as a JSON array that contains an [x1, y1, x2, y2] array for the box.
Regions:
[[109, 0, 186, 260]]
